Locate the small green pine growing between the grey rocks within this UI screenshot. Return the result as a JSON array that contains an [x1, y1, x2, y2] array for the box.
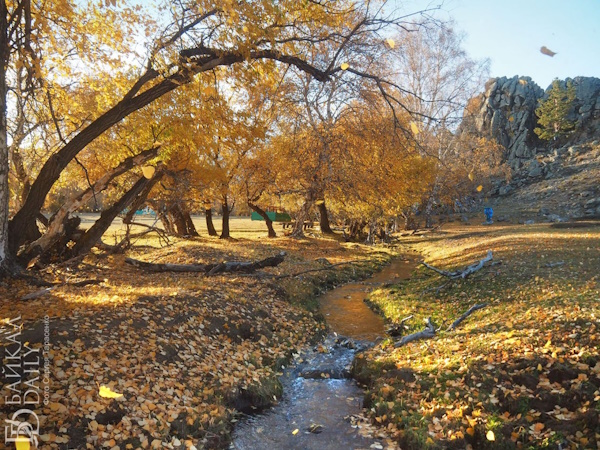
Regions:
[[534, 79, 575, 141]]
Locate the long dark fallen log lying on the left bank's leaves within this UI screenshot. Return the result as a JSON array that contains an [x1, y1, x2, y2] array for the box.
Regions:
[[125, 252, 286, 276]]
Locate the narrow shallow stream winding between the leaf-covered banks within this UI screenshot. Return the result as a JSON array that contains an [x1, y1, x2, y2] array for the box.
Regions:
[[230, 259, 415, 450]]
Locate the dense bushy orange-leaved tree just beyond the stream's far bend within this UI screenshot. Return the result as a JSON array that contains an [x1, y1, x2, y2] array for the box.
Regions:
[[329, 99, 435, 240]]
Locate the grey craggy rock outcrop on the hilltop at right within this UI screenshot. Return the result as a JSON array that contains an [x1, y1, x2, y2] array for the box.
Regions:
[[461, 77, 600, 169]]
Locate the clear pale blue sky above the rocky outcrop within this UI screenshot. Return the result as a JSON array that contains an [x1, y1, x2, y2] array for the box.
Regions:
[[396, 0, 600, 89]]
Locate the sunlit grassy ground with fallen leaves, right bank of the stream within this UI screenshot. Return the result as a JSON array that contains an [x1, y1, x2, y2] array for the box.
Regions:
[[354, 224, 600, 449]]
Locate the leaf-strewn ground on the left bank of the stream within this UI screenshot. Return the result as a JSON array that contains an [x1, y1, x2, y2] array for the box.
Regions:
[[0, 234, 396, 449]]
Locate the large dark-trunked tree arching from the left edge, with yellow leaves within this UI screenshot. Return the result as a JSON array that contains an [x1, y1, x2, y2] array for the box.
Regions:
[[0, 0, 440, 274]]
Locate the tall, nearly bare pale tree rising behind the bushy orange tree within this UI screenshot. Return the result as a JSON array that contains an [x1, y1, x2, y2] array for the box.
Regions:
[[386, 23, 489, 226]]
